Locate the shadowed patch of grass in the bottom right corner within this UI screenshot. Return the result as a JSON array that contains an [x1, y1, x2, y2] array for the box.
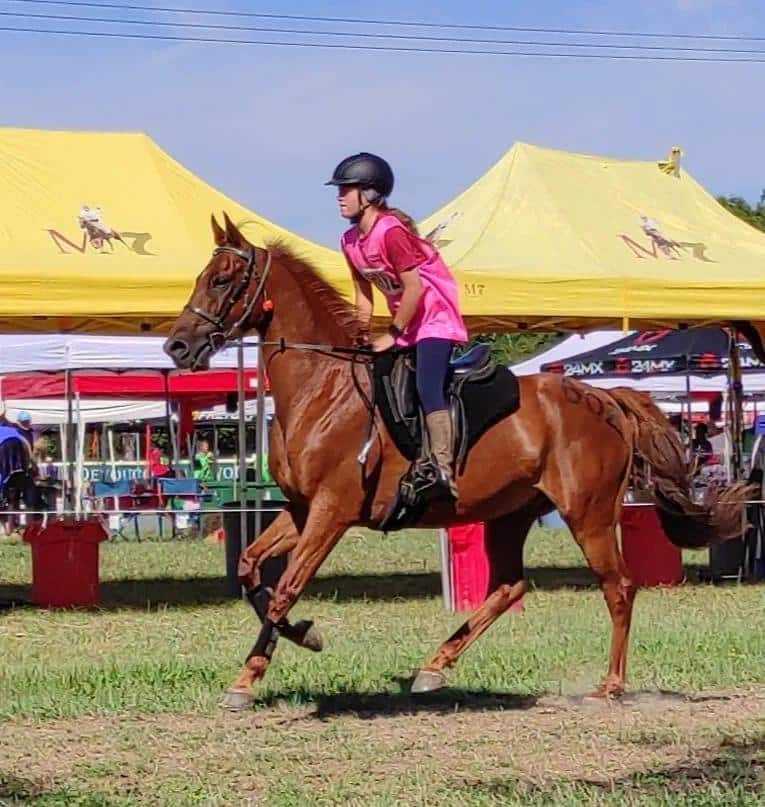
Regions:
[[454, 735, 765, 807]]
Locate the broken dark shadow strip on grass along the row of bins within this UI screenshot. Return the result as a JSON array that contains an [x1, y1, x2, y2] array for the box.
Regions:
[[0, 566, 762, 611]]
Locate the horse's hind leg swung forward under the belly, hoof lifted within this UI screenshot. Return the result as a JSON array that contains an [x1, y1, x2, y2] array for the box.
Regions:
[[412, 513, 536, 693]]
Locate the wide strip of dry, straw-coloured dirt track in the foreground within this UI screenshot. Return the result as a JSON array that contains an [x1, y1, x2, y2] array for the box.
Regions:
[[0, 687, 765, 804]]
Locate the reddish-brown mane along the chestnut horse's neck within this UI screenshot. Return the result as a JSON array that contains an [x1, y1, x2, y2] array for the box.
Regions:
[[268, 242, 363, 345]]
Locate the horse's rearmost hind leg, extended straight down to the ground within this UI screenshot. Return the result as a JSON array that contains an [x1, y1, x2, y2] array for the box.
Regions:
[[571, 524, 637, 698]]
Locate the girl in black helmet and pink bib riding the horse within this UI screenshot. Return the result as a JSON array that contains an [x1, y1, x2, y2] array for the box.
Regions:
[[326, 152, 467, 499]]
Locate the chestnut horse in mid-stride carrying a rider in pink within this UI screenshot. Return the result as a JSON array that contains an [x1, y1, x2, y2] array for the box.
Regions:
[[164, 215, 746, 709]]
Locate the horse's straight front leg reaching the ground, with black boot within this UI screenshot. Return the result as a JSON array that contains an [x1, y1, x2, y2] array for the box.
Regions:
[[223, 497, 351, 709]]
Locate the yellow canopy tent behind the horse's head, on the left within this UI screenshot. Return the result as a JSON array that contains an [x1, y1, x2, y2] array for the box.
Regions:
[[0, 129, 350, 333]]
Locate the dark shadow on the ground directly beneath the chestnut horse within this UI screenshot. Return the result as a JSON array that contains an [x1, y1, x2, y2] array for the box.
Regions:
[[258, 678, 537, 720]]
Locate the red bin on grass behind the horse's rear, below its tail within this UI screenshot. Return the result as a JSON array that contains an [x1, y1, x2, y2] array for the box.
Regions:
[[621, 504, 683, 586]]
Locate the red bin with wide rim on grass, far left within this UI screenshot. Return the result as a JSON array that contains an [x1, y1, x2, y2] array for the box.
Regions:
[[24, 520, 108, 608]]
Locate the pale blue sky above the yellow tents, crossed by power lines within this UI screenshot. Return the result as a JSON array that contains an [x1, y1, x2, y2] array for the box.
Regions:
[[0, 0, 765, 246]]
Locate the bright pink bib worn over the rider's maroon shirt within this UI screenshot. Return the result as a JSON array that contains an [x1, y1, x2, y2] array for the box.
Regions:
[[340, 213, 467, 347]]
